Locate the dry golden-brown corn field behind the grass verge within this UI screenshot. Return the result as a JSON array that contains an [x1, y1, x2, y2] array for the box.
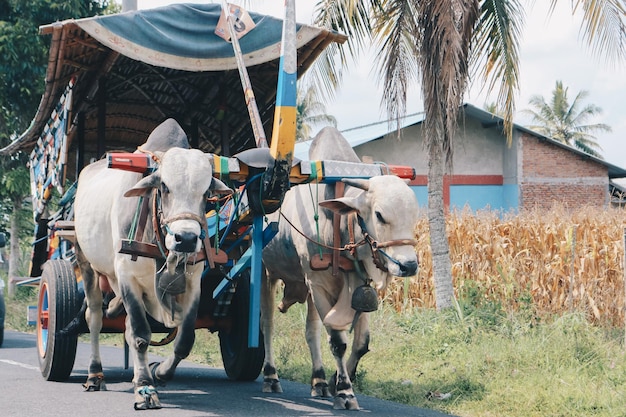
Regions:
[[385, 207, 626, 325]]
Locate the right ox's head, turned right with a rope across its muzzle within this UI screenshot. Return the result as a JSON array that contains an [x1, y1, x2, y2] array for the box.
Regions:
[[320, 175, 418, 289]]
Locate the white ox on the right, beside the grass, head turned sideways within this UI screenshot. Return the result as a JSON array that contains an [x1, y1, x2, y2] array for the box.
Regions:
[[261, 128, 418, 409]]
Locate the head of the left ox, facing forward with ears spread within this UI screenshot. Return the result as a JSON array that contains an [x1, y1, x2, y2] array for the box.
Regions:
[[124, 148, 233, 258]]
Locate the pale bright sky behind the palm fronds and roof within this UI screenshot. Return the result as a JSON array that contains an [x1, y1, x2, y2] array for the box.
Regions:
[[133, 0, 626, 168]]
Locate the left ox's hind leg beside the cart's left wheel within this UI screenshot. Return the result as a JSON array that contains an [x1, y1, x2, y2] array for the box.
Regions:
[[76, 244, 106, 392]]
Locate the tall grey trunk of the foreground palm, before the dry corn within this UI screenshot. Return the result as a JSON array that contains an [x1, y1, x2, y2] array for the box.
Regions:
[[419, 0, 480, 310]]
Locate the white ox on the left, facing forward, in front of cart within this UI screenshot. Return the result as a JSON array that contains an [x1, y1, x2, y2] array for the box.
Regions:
[[74, 119, 231, 409]]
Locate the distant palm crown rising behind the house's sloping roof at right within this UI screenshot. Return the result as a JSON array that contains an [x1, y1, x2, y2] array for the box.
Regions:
[[524, 81, 611, 158]]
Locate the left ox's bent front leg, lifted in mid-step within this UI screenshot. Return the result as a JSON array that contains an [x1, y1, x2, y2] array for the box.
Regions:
[[150, 293, 200, 385]]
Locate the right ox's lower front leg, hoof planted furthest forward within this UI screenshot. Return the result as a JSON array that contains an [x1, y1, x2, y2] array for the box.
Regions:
[[329, 329, 359, 410]]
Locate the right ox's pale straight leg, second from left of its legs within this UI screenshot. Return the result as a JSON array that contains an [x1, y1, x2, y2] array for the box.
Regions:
[[305, 294, 331, 397]]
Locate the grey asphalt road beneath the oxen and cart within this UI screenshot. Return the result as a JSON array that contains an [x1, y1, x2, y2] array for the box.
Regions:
[[0, 331, 450, 417]]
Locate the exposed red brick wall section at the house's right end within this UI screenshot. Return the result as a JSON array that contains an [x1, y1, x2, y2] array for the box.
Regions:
[[519, 133, 609, 209]]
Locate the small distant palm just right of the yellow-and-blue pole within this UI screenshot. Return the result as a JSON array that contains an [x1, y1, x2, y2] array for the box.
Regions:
[[296, 85, 337, 141]]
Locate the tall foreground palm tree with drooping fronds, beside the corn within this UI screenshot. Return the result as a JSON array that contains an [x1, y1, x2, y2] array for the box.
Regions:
[[315, 0, 626, 309]]
